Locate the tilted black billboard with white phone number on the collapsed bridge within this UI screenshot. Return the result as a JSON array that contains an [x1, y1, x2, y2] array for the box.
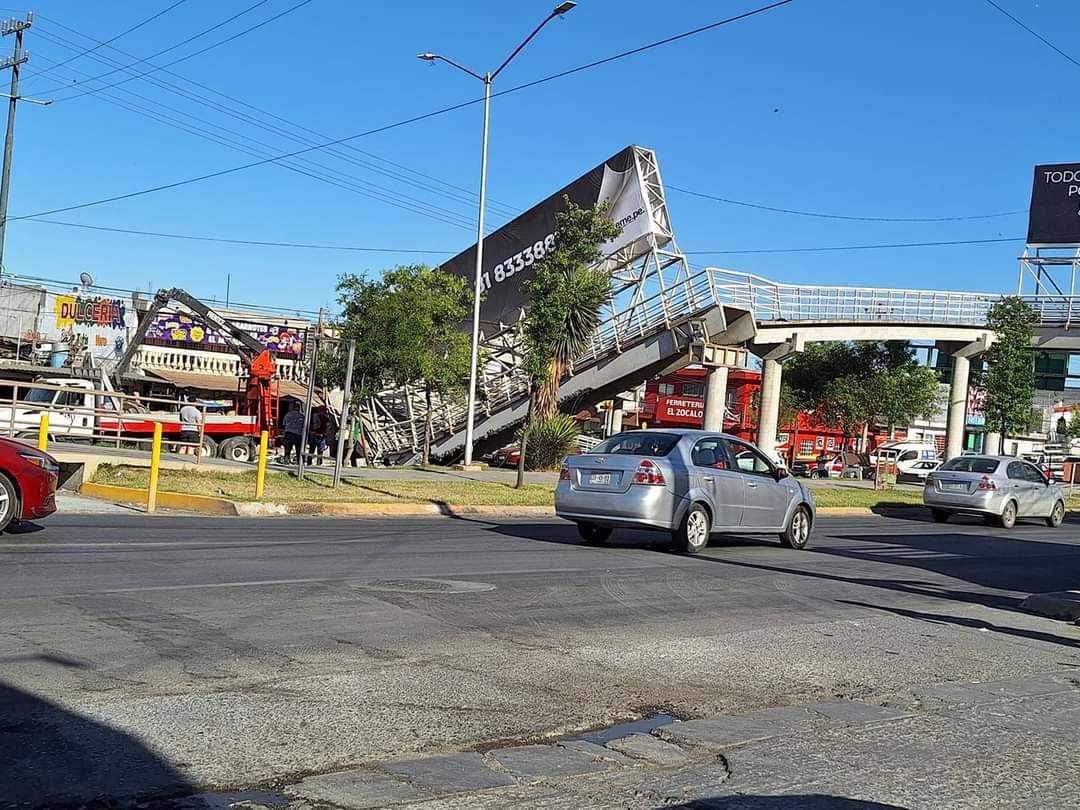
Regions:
[[441, 146, 651, 324]]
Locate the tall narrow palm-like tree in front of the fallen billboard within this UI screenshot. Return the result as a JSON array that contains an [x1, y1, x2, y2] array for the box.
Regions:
[[517, 197, 620, 487]]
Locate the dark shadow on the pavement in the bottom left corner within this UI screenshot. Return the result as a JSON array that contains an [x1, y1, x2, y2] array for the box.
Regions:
[[0, 681, 193, 808]]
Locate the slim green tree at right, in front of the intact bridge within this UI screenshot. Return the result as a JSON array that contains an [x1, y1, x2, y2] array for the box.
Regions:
[[976, 296, 1039, 440]]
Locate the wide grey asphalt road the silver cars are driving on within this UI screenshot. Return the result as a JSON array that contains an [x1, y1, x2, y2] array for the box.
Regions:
[[0, 514, 1080, 806]]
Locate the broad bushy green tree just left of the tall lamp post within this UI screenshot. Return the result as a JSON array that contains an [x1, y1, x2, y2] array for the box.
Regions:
[[337, 265, 472, 464]]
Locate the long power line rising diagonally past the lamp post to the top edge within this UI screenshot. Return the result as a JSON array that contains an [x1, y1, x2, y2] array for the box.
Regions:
[[9, 0, 794, 220]]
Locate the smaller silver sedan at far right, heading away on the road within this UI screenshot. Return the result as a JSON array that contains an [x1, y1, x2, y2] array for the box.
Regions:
[[922, 456, 1065, 529]]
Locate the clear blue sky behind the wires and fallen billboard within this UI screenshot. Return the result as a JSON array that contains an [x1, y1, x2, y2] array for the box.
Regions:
[[2, 0, 1080, 308]]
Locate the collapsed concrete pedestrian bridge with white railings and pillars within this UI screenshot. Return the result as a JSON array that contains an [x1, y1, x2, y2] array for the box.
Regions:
[[366, 261, 1080, 460]]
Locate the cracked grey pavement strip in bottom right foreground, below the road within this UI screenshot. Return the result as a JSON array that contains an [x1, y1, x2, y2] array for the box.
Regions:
[[177, 672, 1080, 810]]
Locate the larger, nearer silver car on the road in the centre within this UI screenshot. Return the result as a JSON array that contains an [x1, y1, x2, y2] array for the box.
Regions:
[[555, 430, 815, 554]]
